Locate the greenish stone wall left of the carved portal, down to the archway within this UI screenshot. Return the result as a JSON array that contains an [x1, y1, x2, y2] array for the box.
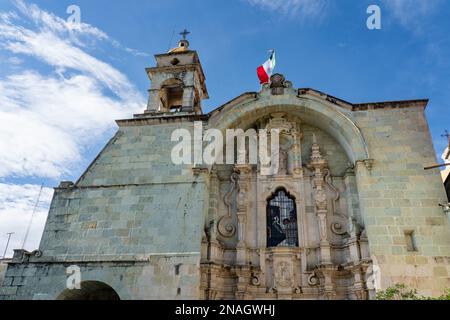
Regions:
[[3, 118, 208, 299]]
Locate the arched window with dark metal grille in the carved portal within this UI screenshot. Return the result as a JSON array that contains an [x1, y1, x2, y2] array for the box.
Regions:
[[267, 189, 298, 247]]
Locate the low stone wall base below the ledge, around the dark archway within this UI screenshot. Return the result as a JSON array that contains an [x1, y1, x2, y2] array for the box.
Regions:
[[0, 254, 199, 300]]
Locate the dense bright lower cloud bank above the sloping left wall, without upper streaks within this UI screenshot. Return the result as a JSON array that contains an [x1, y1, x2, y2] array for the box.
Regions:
[[0, 72, 136, 179]]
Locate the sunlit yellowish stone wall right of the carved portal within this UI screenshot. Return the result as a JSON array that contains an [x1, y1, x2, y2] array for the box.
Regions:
[[354, 107, 450, 295]]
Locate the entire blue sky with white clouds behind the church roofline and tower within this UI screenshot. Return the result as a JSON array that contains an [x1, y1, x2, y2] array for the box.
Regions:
[[0, 0, 450, 254]]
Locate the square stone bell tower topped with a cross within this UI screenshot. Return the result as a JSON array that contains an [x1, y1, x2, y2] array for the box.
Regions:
[[145, 29, 208, 114]]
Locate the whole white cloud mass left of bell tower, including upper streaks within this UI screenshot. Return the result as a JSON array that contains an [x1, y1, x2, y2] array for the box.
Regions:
[[0, 1, 145, 179]]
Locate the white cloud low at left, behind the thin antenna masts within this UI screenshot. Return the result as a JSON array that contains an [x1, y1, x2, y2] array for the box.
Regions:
[[0, 183, 53, 257]]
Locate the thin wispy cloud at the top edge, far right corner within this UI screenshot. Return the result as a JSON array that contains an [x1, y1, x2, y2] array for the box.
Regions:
[[383, 0, 443, 32]]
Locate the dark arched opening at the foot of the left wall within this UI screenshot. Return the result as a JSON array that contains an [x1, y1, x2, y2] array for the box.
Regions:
[[56, 281, 120, 300]]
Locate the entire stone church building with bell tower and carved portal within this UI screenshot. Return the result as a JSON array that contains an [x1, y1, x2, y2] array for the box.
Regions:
[[0, 40, 450, 299]]
